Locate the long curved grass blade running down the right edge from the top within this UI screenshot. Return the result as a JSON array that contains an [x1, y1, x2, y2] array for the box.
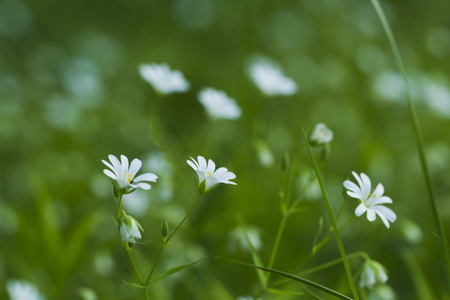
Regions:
[[370, 0, 450, 283]]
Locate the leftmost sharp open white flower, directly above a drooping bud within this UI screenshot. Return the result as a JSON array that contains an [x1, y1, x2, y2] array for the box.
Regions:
[[102, 154, 158, 194]]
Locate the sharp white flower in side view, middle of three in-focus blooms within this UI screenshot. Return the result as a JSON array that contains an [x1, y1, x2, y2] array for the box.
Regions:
[[187, 155, 236, 193]]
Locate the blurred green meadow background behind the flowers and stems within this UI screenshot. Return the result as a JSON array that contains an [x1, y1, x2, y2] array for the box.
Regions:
[[0, 0, 450, 300]]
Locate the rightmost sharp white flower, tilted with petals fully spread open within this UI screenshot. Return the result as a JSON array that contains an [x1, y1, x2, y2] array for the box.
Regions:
[[344, 172, 397, 228]]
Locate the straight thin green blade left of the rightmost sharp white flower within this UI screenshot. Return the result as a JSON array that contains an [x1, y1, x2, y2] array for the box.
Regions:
[[303, 131, 359, 300]]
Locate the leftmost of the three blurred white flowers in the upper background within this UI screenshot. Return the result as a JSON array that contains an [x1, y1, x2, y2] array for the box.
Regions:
[[139, 63, 190, 95]]
